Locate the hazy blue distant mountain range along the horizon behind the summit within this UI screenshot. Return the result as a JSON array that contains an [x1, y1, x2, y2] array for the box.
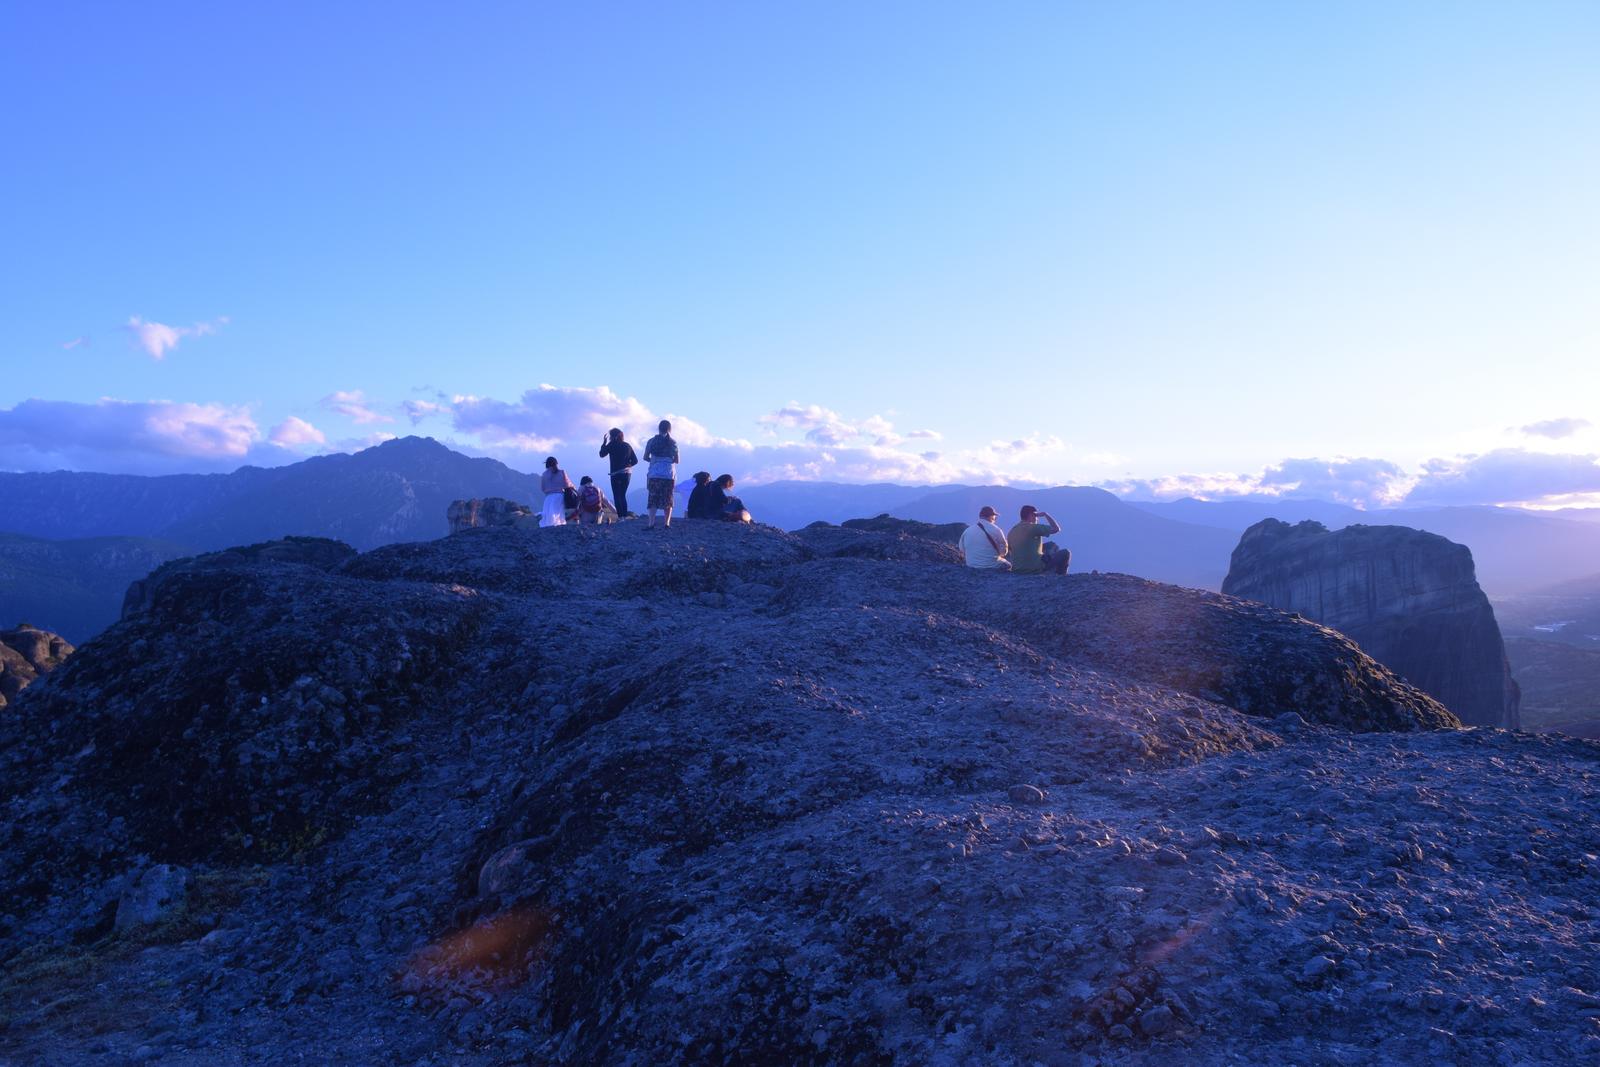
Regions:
[[9, 437, 1600, 641]]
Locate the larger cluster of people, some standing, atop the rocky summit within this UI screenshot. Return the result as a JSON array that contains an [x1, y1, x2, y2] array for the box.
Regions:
[[539, 419, 750, 530]]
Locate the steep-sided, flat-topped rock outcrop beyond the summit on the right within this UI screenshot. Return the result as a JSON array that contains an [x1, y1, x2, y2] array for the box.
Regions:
[[1222, 518, 1520, 729]]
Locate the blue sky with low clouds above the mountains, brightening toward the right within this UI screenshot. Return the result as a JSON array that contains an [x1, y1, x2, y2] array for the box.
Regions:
[[0, 0, 1600, 504]]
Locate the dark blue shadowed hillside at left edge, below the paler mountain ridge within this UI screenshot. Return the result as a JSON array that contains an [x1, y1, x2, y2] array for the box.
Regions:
[[0, 533, 194, 645]]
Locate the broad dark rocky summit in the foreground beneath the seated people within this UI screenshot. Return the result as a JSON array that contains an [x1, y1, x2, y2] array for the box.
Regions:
[[0, 522, 1600, 1065]]
